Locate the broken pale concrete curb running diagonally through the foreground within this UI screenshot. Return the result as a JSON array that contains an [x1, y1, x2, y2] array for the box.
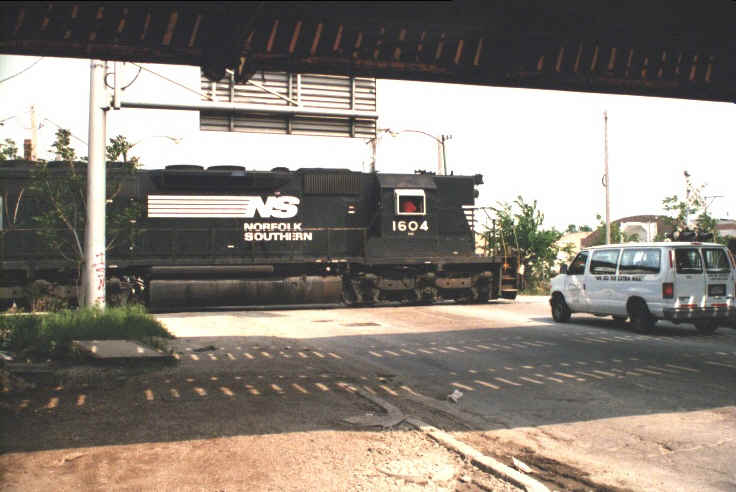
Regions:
[[354, 388, 550, 492]]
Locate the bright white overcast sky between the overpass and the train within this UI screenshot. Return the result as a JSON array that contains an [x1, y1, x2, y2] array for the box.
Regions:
[[0, 56, 736, 230]]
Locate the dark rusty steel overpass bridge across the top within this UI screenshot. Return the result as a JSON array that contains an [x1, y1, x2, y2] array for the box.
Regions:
[[0, 0, 736, 102]]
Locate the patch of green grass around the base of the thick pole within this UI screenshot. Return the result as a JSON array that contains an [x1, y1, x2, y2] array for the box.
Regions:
[[0, 306, 174, 358]]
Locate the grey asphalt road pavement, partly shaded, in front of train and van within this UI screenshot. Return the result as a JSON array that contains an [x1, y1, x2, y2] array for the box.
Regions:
[[1, 297, 736, 491]]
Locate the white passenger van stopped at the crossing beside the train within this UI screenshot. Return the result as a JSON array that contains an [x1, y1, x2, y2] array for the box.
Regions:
[[549, 242, 736, 333]]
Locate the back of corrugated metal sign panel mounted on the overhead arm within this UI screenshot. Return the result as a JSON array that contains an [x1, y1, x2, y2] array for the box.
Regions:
[[199, 72, 378, 138]]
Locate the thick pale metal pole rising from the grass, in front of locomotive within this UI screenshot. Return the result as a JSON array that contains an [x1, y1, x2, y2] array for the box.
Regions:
[[83, 60, 106, 308]]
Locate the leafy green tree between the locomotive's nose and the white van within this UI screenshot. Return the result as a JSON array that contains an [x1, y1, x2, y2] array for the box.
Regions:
[[484, 196, 562, 287]]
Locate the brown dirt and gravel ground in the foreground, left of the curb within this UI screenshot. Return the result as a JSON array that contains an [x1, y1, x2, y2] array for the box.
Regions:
[[0, 358, 518, 492]]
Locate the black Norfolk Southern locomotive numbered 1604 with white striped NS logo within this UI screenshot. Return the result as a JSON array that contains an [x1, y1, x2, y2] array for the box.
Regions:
[[0, 161, 517, 309]]
